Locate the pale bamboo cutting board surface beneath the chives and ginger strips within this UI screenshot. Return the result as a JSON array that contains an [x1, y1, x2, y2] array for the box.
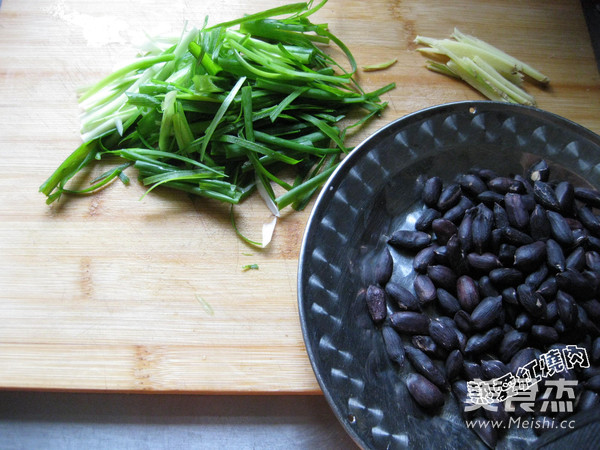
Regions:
[[0, 0, 600, 393]]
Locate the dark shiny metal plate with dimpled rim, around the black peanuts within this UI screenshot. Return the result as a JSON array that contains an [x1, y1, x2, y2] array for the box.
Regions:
[[298, 101, 600, 448]]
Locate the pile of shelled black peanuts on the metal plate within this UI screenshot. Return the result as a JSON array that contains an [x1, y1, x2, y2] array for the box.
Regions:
[[366, 160, 600, 446]]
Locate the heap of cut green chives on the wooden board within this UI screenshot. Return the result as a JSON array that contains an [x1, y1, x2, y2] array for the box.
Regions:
[[40, 0, 394, 246]]
